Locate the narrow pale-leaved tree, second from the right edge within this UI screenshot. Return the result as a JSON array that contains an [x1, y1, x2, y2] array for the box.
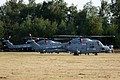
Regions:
[[99, 0, 111, 35]]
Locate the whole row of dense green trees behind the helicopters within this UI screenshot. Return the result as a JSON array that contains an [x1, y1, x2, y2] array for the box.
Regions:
[[0, 0, 120, 48]]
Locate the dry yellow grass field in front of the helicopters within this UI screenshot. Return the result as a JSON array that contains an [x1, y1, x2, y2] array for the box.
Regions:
[[0, 52, 120, 80]]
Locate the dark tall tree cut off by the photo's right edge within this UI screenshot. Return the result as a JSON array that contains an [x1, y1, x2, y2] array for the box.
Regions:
[[111, 0, 120, 47]]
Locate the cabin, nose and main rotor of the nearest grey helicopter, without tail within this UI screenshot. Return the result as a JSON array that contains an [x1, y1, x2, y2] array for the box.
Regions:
[[55, 35, 115, 55]]
